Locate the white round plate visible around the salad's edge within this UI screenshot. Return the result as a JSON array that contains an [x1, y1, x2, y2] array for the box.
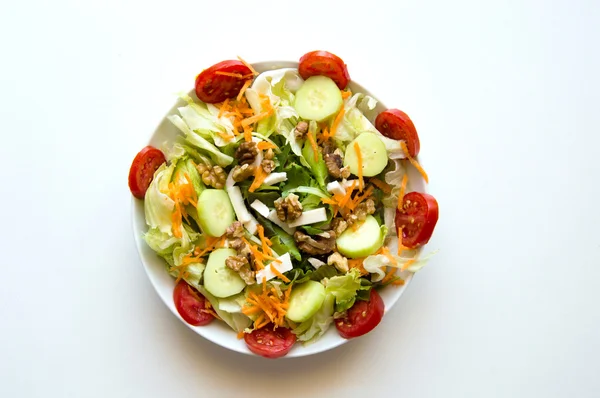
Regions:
[[132, 61, 426, 358]]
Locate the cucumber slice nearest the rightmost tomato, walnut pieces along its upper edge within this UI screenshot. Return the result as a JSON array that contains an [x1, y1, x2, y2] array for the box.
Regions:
[[335, 216, 383, 258]]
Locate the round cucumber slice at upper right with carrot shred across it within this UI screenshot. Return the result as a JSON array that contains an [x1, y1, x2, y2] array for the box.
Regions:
[[344, 133, 388, 177]]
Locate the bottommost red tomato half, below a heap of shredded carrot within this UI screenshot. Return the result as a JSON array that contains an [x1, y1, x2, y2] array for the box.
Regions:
[[244, 324, 296, 358]]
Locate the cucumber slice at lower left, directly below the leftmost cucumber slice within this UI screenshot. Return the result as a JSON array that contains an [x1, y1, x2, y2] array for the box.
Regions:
[[204, 249, 246, 298]]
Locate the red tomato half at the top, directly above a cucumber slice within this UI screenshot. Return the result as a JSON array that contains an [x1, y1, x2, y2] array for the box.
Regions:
[[298, 51, 350, 90]]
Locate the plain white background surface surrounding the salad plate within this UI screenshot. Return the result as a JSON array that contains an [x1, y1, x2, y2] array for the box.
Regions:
[[0, 0, 600, 397]]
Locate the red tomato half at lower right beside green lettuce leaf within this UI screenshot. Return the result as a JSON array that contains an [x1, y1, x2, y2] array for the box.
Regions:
[[335, 289, 385, 339]]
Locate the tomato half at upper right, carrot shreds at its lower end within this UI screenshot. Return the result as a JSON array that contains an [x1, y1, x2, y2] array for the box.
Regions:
[[375, 109, 421, 158]]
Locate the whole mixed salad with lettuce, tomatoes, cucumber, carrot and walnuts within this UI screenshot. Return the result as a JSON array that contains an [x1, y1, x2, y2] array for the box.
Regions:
[[129, 51, 438, 358]]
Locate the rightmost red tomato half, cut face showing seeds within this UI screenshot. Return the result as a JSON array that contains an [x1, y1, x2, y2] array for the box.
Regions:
[[396, 192, 439, 248]]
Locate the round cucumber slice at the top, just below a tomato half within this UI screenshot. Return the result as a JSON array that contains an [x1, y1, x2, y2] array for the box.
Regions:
[[294, 76, 343, 122]]
